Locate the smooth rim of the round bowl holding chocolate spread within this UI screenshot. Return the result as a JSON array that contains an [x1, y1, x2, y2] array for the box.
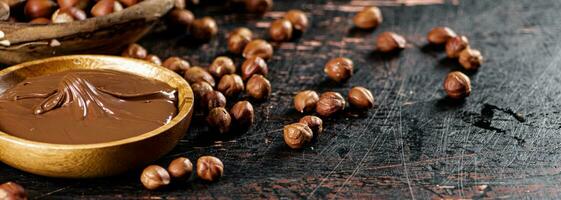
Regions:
[[0, 54, 194, 150]]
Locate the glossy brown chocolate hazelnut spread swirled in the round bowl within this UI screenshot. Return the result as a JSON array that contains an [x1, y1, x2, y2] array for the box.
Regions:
[[0, 70, 177, 144]]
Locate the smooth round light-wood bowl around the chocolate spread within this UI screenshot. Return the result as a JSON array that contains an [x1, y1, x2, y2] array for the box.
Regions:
[[0, 55, 193, 178]]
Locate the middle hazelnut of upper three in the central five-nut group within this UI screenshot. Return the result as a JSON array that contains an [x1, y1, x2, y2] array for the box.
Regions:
[[316, 92, 346, 117]]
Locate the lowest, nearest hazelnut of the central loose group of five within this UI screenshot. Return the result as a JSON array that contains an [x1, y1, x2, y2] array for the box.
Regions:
[[283, 123, 314, 149]]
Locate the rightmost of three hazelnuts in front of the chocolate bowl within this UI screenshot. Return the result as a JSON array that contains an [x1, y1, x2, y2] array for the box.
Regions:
[[197, 156, 224, 181]]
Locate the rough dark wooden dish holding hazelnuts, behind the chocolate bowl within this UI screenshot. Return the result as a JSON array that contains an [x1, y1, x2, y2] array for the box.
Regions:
[[0, 0, 174, 64]]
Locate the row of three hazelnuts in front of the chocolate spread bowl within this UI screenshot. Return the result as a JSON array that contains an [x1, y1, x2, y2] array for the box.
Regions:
[[140, 156, 224, 190]]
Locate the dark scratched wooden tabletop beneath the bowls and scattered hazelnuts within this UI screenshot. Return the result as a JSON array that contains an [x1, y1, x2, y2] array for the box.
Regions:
[[4, 0, 561, 199]]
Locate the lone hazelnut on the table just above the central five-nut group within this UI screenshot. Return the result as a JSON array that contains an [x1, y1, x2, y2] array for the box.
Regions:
[[323, 57, 353, 82]]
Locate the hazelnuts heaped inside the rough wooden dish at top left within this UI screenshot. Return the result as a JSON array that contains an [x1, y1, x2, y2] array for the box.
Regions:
[[0, 0, 149, 24]]
